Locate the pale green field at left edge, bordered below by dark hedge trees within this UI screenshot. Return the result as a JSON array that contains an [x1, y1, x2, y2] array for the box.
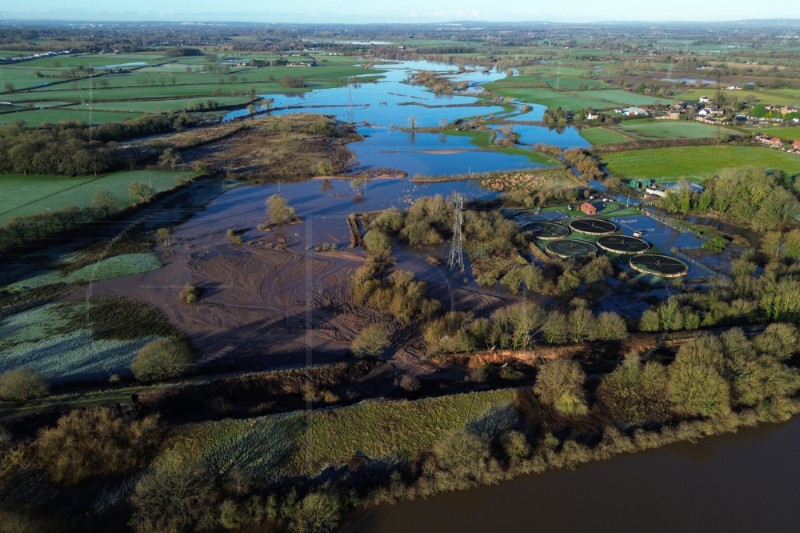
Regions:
[[0, 170, 193, 224]]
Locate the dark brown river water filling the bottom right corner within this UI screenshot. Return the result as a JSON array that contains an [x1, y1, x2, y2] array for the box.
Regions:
[[342, 417, 800, 533]]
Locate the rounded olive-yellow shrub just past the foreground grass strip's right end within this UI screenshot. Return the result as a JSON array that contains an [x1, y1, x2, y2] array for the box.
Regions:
[[533, 359, 589, 415]]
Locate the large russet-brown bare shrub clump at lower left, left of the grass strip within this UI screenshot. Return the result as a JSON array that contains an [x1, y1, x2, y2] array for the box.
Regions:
[[34, 407, 161, 484]]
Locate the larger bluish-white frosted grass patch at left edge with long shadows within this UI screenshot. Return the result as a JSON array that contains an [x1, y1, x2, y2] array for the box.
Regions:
[[0, 302, 157, 383]]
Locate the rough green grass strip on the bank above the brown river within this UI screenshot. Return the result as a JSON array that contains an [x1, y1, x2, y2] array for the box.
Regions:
[[175, 390, 516, 480]]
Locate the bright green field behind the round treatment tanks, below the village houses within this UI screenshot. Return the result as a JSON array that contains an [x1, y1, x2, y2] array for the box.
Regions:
[[602, 146, 800, 178]]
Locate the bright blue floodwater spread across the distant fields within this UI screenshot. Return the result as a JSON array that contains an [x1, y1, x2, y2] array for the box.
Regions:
[[223, 61, 589, 176]]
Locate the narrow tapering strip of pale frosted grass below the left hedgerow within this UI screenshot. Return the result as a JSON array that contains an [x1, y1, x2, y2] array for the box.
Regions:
[[8, 253, 161, 290]]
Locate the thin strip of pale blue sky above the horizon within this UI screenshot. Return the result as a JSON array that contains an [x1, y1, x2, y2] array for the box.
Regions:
[[0, 0, 800, 23]]
